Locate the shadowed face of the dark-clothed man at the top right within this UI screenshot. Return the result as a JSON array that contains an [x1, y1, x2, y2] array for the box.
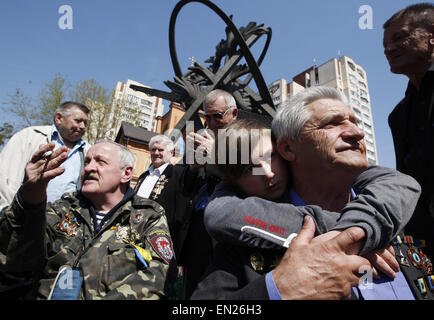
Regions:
[[383, 18, 434, 76]]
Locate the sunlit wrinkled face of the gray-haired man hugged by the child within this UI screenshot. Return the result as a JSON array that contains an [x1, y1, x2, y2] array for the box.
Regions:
[[292, 99, 369, 174]]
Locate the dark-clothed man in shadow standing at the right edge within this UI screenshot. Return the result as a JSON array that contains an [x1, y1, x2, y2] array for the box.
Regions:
[[383, 3, 434, 256]]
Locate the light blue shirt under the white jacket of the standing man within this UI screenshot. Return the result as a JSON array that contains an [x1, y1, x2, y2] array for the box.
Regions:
[[47, 126, 86, 202]]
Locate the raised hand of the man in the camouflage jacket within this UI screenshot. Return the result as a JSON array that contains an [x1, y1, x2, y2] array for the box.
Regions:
[[21, 142, 68, 205]]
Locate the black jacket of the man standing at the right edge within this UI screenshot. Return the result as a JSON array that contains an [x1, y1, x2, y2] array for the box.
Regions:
[[389, 64, 434, 256]]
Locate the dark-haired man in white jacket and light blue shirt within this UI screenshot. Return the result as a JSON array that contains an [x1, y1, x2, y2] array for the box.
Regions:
[[0, 101, 89, 209]]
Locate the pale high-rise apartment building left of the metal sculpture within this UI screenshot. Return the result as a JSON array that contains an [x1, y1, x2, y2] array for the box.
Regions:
[[115, 79, 164, 133]]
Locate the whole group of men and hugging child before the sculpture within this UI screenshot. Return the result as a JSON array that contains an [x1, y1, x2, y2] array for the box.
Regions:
[[0, 3, 434, 300]]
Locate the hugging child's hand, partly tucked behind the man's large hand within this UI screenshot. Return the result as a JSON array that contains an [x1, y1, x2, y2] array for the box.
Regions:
[[364, 246, 400, 279]]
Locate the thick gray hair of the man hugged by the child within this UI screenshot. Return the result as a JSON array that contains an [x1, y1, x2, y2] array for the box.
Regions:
[[271, 86, 348, 141]]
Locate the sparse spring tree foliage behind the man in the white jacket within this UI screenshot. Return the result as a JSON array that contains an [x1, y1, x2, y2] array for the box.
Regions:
[[0, 74, 141, 145]]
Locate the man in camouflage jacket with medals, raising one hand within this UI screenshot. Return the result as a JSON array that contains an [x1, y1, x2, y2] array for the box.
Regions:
[[0, 142, 173, 299]]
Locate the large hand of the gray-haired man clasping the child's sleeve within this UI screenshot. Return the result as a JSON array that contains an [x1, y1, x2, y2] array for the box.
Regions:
[[273, 216, 370, 300]]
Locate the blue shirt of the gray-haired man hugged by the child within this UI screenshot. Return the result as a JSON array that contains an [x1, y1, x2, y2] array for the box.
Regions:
[[265, 189, 414, 300]]
